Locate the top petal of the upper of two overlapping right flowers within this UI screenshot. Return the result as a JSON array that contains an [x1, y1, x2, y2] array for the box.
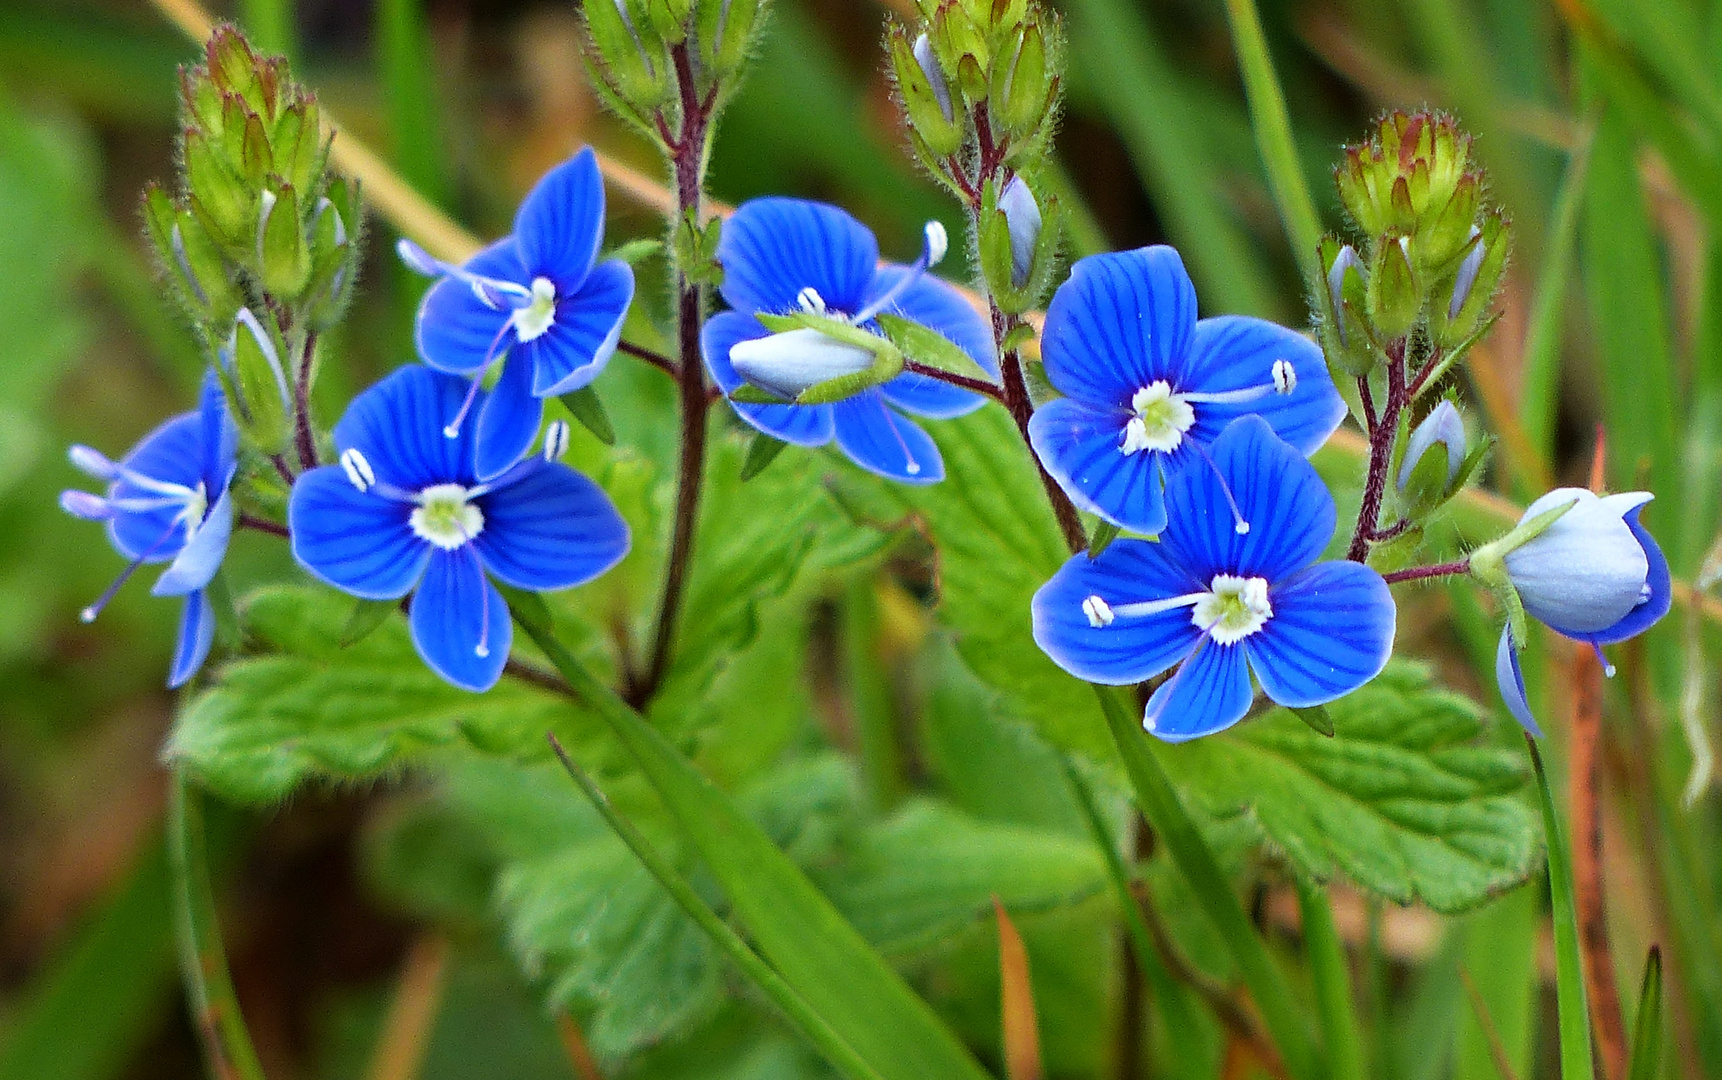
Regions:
[[1040, 246, 1195, 408]]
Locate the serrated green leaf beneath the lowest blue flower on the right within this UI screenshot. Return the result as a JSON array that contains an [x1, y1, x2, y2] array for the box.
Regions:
[[1161, 661, 1536, 913]]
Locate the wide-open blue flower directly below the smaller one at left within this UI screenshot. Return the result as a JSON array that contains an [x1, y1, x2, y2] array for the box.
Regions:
[[288, 367, 629, 691]]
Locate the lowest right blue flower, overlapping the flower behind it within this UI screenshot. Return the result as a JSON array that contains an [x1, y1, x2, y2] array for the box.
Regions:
[[1033, 417, 1395, 742]]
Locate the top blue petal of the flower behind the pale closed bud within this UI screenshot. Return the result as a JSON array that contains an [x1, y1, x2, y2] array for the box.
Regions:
[[718, 198, 878, 315]]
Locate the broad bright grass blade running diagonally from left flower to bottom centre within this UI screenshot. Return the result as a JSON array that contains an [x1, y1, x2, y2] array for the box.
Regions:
[[515, 610, 987, 1080]]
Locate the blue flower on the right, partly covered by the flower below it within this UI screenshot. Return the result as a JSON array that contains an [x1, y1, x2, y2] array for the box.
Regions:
[[1028, 246, 1345, 534]]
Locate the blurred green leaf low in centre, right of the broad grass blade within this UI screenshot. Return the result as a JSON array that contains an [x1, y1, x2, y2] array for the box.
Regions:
[[827, 801, 1106, 956]]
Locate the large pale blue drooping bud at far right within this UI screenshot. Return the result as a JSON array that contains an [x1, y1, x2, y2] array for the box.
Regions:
[[1505, 487, 1653, 637]]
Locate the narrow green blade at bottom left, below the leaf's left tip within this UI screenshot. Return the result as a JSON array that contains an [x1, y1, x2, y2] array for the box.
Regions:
[[167, 775, 265, 1080]]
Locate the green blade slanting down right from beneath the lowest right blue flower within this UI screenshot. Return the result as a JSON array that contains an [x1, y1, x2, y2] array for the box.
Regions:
[[1093, 686, 1324, 1080]]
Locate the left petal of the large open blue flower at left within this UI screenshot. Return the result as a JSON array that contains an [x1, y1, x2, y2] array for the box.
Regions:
[[288, 465, 431, 599]]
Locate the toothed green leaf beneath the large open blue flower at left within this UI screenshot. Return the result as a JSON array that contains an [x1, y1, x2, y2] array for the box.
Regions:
[[165, 586, 579, 803]]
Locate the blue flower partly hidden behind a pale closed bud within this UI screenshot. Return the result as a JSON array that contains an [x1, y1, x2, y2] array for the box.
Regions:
[[701, 198, 999, 484]]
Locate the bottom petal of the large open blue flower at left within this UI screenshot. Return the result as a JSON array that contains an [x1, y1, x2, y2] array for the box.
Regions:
[[406, 548, 515, 692]]
